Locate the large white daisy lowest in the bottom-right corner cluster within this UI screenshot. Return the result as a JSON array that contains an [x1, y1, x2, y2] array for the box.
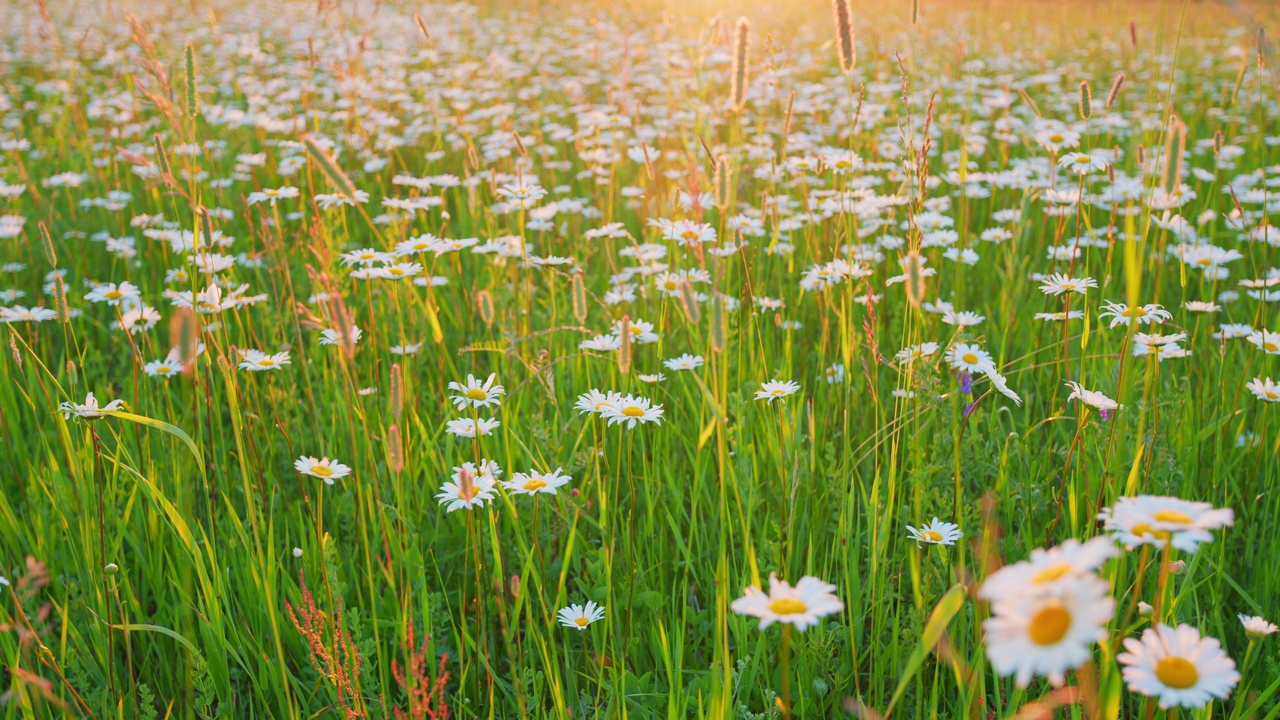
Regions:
[[1116, 625, 1240, 708]]
